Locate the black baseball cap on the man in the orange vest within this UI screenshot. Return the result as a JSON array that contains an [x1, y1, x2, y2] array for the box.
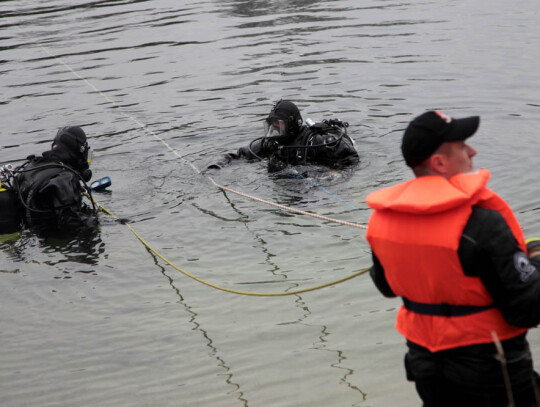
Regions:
[[401, 110, 480, 168]]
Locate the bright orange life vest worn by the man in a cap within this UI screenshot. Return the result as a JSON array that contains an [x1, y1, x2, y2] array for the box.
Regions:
[[366, 170, 526, 352]]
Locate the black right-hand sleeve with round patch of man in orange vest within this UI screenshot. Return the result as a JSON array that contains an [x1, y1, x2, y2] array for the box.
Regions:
[[458, 207, 540, 328]]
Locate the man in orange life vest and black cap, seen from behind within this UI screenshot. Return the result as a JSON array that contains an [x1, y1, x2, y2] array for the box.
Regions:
[[366, 111, 540, 407]]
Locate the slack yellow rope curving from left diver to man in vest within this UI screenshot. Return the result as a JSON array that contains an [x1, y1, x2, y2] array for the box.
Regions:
[[99, 205, 369, 297]]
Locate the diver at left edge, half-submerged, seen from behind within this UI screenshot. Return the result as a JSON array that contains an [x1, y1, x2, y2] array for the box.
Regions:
[[0, 126, 97, 232]]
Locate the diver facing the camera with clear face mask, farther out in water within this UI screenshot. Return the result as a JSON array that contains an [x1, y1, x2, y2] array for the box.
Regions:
[[208, 100, 359, 172]]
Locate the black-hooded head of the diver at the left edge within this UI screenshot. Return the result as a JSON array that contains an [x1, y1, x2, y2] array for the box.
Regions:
[[51, 126, 92, 181]]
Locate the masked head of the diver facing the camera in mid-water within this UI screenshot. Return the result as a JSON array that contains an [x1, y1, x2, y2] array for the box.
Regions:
[[264, 99, 302, 139]]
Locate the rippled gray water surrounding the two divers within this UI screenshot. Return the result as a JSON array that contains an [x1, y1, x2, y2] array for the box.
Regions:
[[0, 0, 540, 407]]
